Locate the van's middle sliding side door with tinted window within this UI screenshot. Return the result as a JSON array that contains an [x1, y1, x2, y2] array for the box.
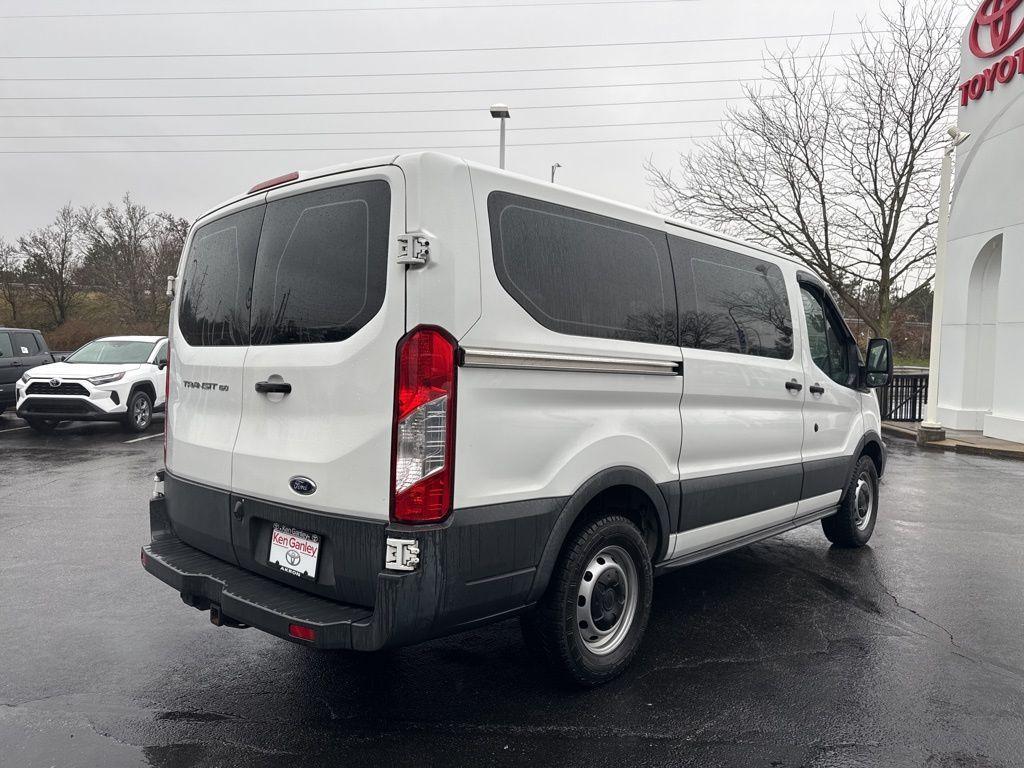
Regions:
[[670, 246, 806, 557]]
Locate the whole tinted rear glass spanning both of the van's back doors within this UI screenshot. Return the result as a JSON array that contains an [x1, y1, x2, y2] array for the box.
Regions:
[[178, 181, 391, 346]]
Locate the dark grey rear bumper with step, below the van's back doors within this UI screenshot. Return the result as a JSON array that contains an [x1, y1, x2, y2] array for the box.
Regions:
[[141, 481, 560, 650]]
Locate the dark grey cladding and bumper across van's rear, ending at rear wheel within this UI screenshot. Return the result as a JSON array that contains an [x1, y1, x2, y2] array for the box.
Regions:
[[142, 474, 565, 650]]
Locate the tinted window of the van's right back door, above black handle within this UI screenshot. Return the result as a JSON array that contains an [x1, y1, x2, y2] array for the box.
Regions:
[[252, 181, 391, 344]]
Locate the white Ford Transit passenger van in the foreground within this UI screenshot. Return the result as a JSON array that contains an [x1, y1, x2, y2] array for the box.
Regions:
[[141, 154, 891, 685]]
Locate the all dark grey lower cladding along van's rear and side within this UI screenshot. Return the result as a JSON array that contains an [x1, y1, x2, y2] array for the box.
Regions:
[[142, 442, 884, 650]]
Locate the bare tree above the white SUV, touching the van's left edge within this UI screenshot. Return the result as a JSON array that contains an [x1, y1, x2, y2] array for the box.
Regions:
[[81, 195, 188, 326]]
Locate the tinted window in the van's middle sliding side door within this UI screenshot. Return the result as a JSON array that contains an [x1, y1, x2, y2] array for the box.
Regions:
[[669, 236, 793, 359]]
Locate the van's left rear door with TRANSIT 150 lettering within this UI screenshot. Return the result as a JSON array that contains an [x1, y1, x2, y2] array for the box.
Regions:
[[165, 195, 265, 560]]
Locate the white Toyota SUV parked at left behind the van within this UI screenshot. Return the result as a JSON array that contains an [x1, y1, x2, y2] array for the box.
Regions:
[[16, 336, 167, 432]]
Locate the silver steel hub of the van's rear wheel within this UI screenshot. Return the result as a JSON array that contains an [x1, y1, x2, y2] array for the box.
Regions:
[[577, 546, 639, 655]]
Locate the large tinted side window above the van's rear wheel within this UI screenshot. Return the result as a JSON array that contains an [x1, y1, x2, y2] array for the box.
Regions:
[[487, 191, 676, 345]]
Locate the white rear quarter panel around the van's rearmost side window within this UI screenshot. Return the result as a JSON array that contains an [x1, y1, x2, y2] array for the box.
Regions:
[[455, 166, 682, 518]]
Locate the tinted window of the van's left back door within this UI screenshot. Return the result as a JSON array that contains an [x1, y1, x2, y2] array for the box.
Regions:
[[178, 206, 264, 346]]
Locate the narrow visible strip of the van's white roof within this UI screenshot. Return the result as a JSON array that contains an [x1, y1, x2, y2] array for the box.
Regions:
[[196, 152, 803, 266]]
